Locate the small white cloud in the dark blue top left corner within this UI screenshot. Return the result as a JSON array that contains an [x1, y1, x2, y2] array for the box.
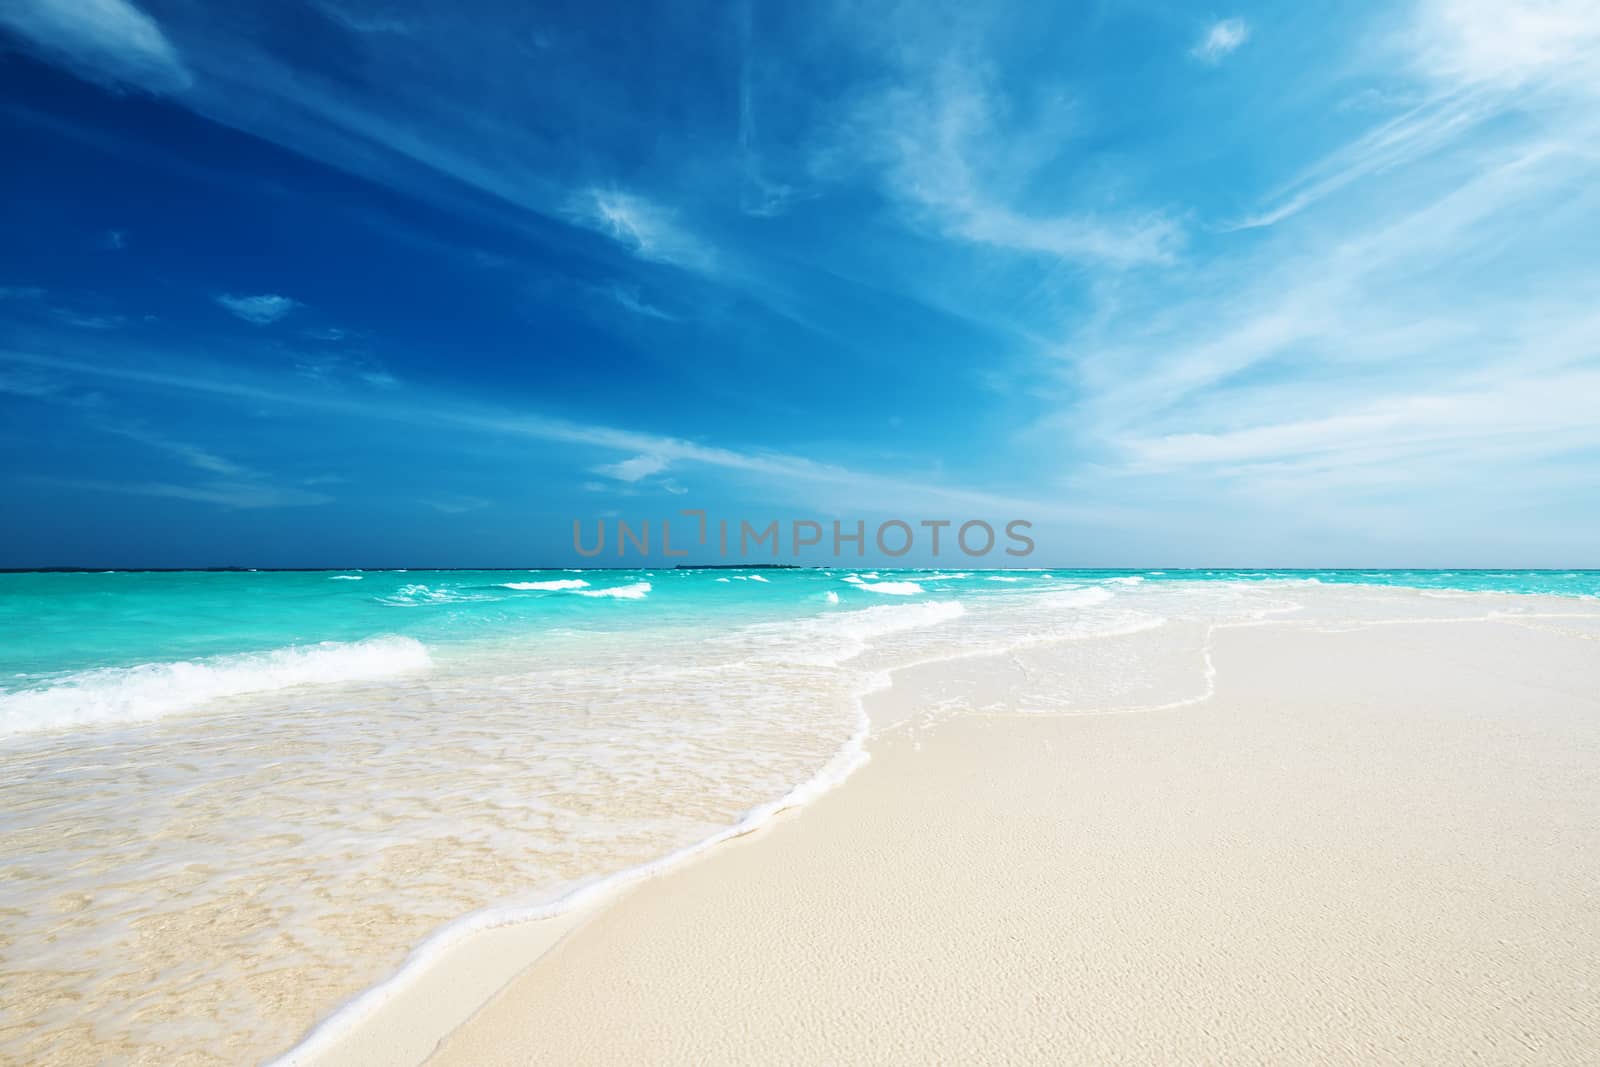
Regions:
[[0, 0, 194, 93]]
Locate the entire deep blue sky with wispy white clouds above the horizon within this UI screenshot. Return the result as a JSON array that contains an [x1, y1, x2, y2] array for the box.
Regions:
[[0, 0, 1600, 568]]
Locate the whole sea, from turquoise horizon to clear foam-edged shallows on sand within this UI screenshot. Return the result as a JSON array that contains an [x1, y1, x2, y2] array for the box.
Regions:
[[0, 568, 1600, 1064]]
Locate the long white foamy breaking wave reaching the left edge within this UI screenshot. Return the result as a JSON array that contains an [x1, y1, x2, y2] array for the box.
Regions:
[[0, 637, 434, 736]]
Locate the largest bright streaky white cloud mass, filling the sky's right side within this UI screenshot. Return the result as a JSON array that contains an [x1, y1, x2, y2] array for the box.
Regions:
[[1048, 3, 1600, 531]]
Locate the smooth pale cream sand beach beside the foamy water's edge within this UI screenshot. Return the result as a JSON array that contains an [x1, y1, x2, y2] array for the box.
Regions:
[[419, 622, 1600, 1065]]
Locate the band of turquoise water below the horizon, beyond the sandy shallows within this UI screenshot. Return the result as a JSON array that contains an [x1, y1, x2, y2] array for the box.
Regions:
[[0, 569, 1600, 693]]
